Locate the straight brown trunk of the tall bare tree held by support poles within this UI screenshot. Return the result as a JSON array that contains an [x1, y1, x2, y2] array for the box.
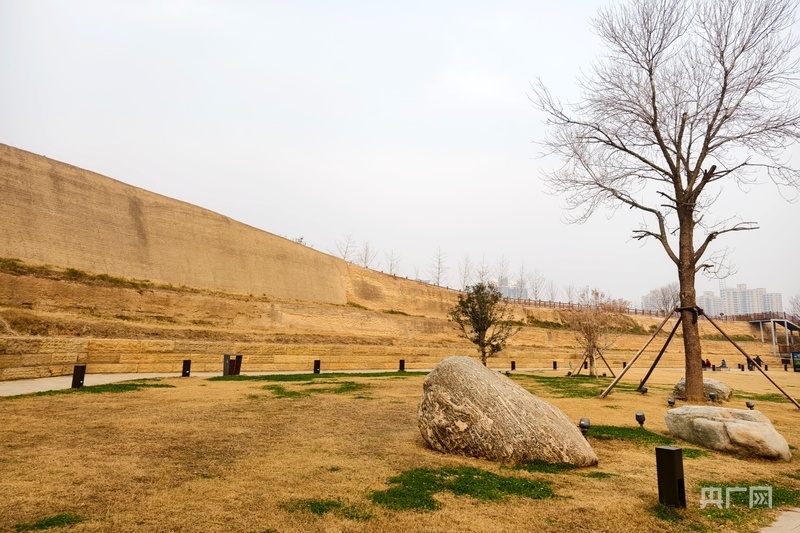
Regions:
[[678, 209, 704, 403]]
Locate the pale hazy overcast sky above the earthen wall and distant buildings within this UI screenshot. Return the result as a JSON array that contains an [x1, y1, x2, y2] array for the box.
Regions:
[[0, 0, 800, 304]]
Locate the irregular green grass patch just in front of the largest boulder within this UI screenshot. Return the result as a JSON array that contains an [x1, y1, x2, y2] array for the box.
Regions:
[[371, 467, 555, 511]]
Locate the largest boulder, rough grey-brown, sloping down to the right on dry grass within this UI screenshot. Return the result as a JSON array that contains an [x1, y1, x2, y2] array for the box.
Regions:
[[418, 357, 597, 466]]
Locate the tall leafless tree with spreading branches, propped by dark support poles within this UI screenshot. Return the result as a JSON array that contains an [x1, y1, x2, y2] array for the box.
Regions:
[[533, 0, 800, 402]]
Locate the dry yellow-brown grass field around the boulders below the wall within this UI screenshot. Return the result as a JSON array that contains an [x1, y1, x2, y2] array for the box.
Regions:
[[0, 369, 800, 532]]
